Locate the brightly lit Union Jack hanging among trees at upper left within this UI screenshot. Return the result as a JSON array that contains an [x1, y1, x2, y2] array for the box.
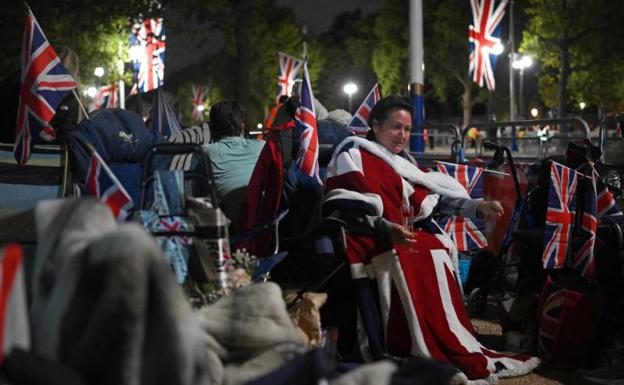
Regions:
[[130, 17, 166, 95]]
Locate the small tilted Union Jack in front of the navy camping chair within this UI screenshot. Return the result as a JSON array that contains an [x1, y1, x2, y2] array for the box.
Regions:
[[84, 150, 134, 221]]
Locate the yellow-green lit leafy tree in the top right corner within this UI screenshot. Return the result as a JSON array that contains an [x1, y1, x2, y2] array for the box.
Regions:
[[521, 0, 624, 117]]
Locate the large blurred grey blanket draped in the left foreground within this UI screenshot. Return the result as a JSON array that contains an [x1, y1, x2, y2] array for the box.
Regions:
[[31, 199, 216, 385]]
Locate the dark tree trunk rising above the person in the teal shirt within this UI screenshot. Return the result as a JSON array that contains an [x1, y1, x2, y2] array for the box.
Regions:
[[234, 0, 252, 121]]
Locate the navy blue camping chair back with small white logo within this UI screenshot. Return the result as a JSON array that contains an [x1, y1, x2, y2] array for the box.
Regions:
[[67, 108, 165, 202]]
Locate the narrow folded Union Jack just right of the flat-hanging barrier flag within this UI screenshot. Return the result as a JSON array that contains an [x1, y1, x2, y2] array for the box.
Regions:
[[568, 175, 598, 280]]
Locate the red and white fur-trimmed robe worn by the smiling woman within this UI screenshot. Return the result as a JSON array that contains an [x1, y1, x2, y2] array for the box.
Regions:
[[323, 137, 539, 383]]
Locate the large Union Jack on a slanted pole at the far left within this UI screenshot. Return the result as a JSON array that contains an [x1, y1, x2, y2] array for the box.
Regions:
[[13, 9, 76, 165]]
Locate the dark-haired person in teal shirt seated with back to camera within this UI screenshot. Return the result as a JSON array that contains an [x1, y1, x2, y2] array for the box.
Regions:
[[203, 100, 264, 236]]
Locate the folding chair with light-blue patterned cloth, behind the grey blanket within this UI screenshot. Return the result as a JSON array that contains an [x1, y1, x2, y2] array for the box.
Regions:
[[138, 143, 227, 292]]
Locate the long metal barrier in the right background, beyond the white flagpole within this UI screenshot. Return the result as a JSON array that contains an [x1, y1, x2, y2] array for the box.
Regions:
[[461, 118, 591, 160]]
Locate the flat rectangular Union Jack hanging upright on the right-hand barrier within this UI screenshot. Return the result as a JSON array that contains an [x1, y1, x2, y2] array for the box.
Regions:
[[542, 162, 578, 269]]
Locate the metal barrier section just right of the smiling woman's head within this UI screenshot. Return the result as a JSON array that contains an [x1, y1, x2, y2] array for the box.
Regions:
[[410, 123, 461, 164]]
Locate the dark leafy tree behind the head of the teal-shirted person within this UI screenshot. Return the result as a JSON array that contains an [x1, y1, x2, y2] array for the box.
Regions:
[[177, 0, 300, 123]]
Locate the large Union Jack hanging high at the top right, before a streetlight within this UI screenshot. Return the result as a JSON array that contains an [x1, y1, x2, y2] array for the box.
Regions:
[[468, 0, 507, 91]]
